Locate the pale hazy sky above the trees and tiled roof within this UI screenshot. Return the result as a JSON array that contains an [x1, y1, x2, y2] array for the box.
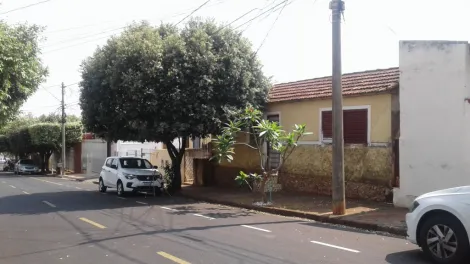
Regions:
[[0, 0, 470, 116]]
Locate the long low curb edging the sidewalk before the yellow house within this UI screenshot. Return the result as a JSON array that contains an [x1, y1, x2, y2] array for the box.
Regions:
[[180, 192, 406, 237]]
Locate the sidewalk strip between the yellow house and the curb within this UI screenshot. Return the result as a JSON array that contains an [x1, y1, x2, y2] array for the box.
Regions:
[[181, 186, 408, 236]]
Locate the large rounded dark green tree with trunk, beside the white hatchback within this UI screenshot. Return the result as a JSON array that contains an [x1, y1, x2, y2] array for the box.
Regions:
[[80, 19, 271, 189]]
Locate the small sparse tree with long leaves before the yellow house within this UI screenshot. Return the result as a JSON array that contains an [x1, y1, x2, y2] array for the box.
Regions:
[[211, 107, 311, 203]]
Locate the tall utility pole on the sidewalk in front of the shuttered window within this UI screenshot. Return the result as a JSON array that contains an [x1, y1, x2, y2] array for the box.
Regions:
[[330, 0, 346, 215]]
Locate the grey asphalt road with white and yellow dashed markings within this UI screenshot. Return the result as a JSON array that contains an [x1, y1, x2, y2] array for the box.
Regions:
[[0, 173, 434, 264]]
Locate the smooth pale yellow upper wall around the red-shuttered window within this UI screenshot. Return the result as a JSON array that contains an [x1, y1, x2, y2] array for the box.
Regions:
[[267, 94, 392, 143]]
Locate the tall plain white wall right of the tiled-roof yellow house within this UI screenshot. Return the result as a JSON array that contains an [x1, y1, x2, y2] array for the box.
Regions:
[[394, 41, 470, 207]]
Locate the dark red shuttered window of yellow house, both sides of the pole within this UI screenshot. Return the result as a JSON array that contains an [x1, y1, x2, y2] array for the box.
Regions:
[[321, 109, 368, 144]]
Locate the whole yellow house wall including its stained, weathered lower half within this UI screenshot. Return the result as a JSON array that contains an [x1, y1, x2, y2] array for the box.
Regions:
[[214, 94, 393, 201]]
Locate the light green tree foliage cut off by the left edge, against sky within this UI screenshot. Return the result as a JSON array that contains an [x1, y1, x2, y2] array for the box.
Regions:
[[0, 21, 47, 124]]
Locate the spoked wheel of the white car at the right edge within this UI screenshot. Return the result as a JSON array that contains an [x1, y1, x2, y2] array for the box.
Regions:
[[419, 214, 470, 264]]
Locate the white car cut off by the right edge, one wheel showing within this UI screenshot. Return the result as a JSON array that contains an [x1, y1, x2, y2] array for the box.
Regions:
[[406, 186, 470, 264]]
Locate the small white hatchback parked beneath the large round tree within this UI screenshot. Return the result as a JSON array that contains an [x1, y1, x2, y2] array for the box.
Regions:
[[98, 157, 164, 196]]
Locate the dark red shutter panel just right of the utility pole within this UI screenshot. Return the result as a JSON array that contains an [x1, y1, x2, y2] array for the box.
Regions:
[[343, 109, 368, 144]]
